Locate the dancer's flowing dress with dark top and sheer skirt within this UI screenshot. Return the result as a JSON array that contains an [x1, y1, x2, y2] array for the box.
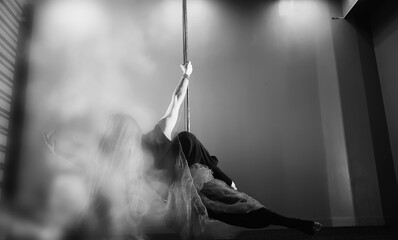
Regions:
[[143, 125, 264, 239]]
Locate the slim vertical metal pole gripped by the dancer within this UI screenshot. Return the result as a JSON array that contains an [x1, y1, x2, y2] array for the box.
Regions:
[[182, 0, 191, 132]]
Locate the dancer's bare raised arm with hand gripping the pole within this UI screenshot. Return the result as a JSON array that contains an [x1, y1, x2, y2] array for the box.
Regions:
[[158, 62, 192, 140]]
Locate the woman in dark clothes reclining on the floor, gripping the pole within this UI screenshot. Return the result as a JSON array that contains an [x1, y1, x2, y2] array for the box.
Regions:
[[45, 63, 322, 238]]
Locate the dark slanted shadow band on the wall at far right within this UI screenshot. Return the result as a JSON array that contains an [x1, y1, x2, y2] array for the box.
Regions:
[[334, 0, 398, 225]]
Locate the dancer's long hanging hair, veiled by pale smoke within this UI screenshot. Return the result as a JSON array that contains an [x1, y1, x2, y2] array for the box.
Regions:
[[90, 113, 144, 203]]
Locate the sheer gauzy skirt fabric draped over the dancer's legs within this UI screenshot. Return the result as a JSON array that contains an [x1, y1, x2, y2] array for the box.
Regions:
[[166, 143, 264, 239]]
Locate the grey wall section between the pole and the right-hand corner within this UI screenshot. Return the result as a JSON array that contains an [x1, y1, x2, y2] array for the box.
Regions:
[[190, 1, 330, 221]]
